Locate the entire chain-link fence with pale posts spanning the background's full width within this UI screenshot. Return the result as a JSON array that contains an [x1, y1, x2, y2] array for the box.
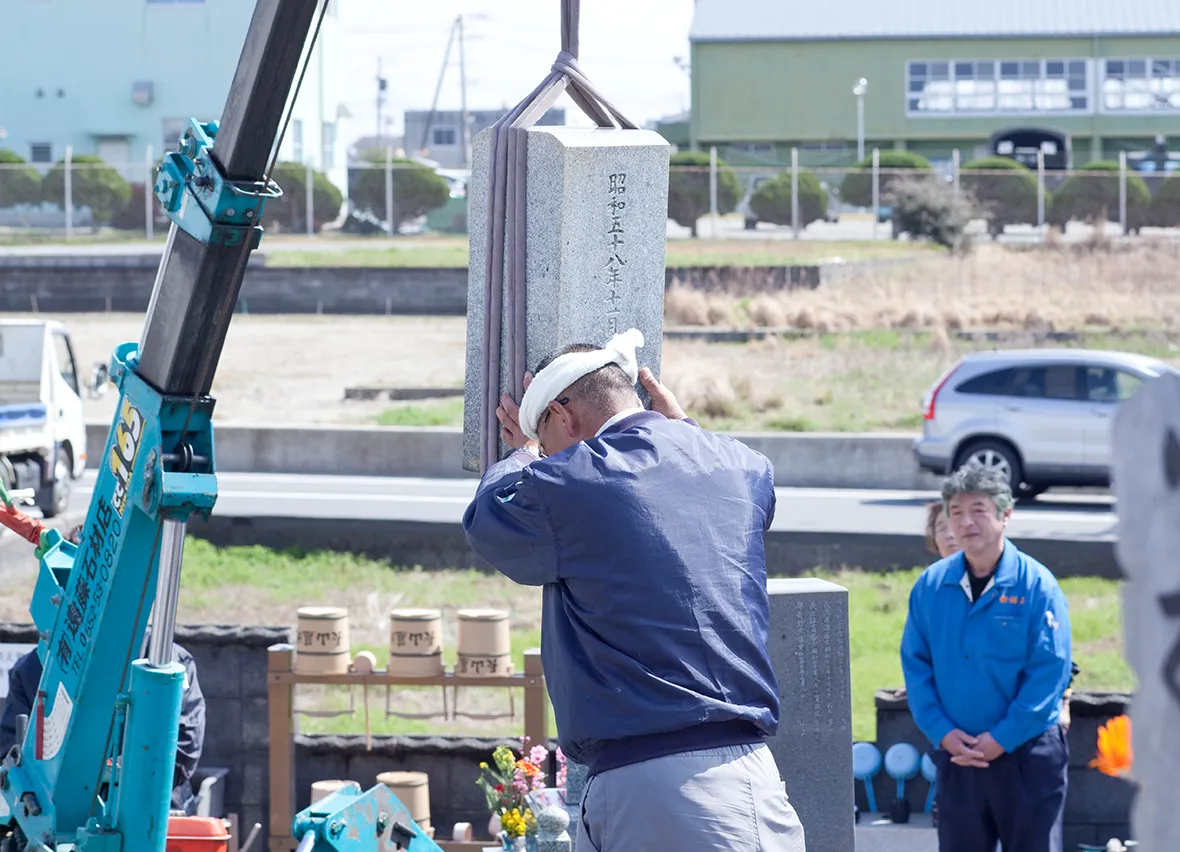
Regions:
[[0, 151, 1180, 242]]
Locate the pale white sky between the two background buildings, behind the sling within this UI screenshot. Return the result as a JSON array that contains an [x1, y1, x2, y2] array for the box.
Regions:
[[340, 0, 694, 142]]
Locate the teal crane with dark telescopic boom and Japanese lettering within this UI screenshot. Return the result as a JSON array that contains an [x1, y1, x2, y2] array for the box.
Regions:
[[0, 0, 439, 852]]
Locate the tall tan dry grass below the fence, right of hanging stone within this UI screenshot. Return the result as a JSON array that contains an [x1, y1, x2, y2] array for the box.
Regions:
[[666, 241, 1180, 332]]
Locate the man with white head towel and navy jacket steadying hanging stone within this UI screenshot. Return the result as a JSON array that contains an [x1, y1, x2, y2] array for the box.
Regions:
[[464, 329, 804, 852]]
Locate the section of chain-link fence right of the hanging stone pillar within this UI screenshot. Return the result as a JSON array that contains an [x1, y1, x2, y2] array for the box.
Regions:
[[689, 151, 1180, 240]]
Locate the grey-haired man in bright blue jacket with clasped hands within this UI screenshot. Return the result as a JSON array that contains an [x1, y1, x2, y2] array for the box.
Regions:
[[902, 466, 1071, 852]]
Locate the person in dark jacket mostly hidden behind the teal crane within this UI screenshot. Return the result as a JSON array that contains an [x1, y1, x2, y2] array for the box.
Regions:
[[0, 640, 205, 814]]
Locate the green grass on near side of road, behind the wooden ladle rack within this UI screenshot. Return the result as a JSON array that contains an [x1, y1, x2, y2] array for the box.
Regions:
[[166, 540, 1134, 739]]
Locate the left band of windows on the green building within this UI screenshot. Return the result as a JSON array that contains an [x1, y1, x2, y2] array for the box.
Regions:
[[906, 59, 1089, 114]]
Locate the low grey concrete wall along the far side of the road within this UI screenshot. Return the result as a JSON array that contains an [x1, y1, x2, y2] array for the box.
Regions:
[[86, 422, 938, 490]]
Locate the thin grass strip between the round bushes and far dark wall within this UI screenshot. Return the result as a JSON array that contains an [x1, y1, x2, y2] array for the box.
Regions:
[[262, 236, 939, 268]]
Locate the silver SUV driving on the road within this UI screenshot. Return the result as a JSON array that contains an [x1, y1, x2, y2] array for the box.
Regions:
[[913, 349, 1176, 496]]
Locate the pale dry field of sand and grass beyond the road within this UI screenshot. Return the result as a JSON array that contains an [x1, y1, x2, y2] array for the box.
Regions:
[[23, 241, 1180, 431]]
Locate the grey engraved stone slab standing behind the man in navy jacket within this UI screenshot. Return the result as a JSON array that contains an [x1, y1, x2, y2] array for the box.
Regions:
[[767, 579, 856, 852]]
